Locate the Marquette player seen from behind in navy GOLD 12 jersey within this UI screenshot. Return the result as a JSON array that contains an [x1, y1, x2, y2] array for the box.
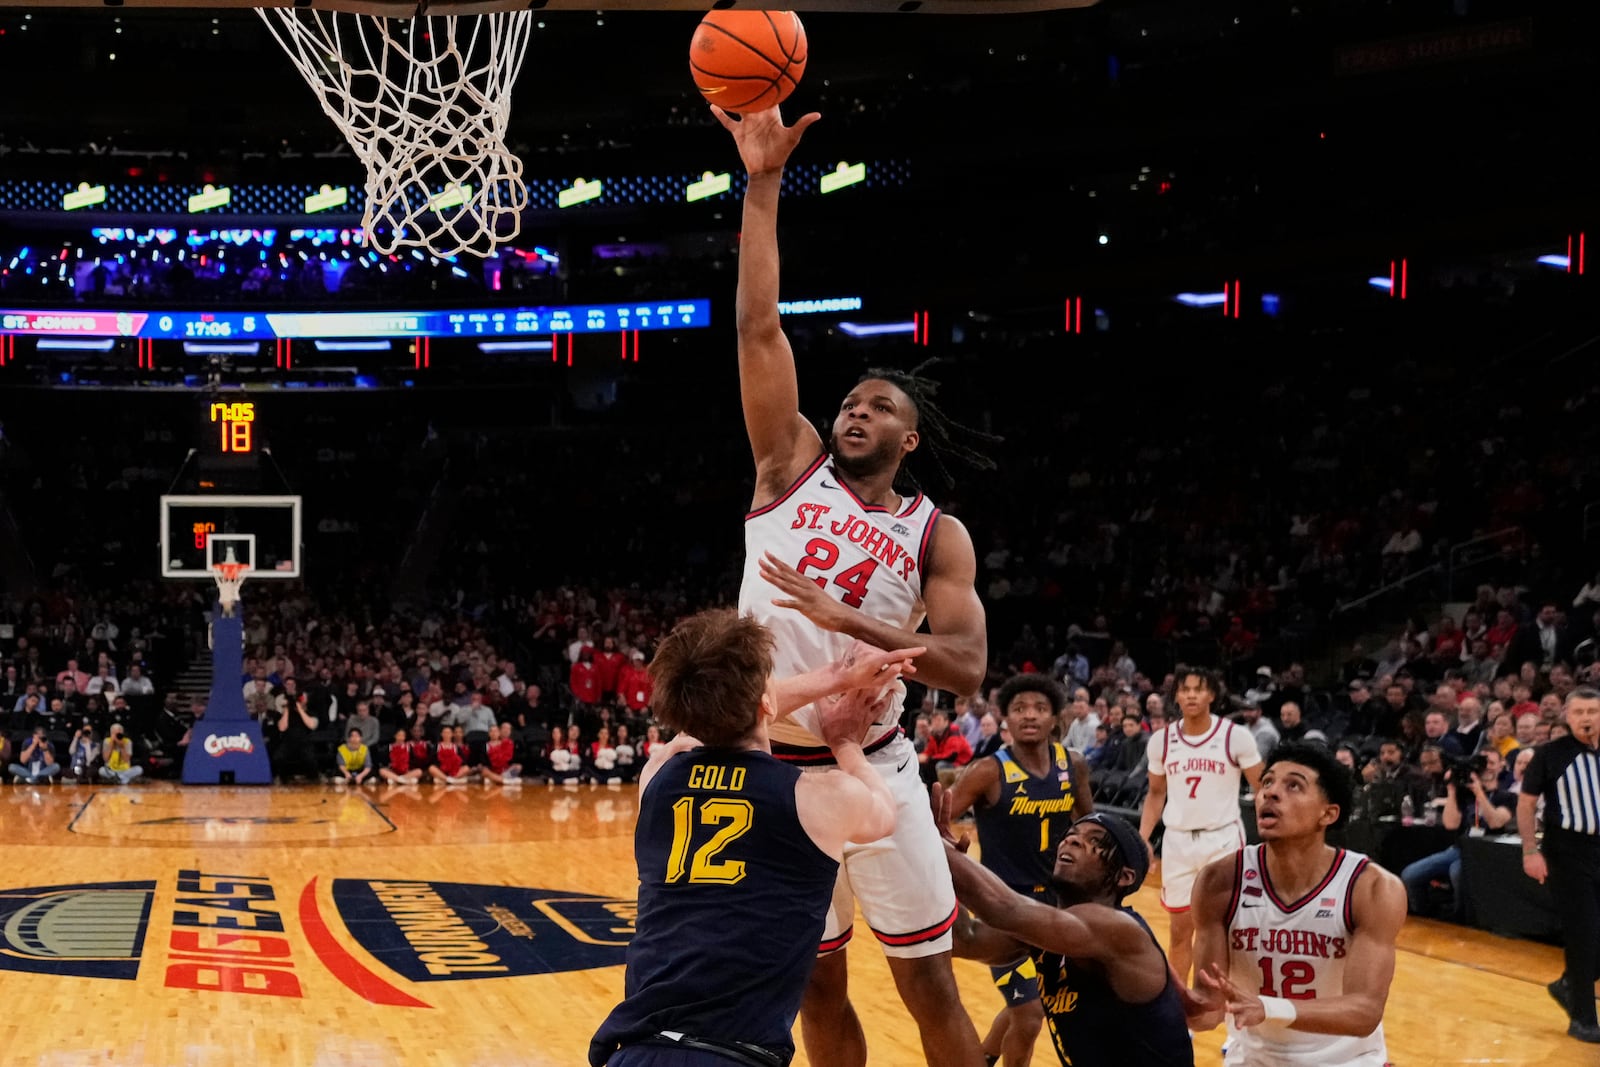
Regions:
[[589, 611, 920, 1067]]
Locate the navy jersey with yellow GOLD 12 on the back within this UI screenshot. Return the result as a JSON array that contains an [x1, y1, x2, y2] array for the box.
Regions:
[[589, 749, 838, 1067]]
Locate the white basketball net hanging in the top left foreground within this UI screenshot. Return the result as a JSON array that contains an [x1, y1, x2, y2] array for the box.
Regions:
[[256, 6, 533, 258]]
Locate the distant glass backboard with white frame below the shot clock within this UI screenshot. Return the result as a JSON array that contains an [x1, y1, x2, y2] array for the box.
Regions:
[[162, 496, 301, 581]]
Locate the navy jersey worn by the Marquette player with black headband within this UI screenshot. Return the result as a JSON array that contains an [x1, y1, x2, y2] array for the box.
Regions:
[[1034, 909, 1195, 1067]]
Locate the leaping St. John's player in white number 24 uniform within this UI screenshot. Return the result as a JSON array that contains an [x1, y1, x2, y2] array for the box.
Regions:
[[712, 107, 987, 1067]]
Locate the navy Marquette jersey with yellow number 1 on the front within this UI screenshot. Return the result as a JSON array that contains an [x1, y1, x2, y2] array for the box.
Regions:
[[973, 742, 1077, 899]]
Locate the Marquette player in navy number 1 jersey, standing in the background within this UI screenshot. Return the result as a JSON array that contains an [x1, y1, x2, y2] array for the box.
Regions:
[[950, 673, 1094, 1067]]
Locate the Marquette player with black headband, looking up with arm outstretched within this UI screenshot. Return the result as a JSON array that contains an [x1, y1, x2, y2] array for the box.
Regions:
[[933, 785, 1195, 1067]]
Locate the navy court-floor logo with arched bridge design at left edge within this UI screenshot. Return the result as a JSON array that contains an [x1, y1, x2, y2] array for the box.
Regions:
[[0, 881, 155, 982]]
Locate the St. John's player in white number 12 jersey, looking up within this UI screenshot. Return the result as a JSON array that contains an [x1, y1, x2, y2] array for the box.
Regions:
[[1192, 742, 1406, 1067]]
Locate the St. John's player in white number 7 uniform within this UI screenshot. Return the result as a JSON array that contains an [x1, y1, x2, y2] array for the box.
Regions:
[[1139, 667, 1261, 982]]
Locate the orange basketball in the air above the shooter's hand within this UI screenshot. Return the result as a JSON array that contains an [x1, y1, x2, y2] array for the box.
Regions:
[[690, 11, 806, 114]]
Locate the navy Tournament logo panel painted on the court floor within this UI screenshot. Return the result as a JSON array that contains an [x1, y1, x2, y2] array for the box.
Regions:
[[333, 878, 638, 982]]
